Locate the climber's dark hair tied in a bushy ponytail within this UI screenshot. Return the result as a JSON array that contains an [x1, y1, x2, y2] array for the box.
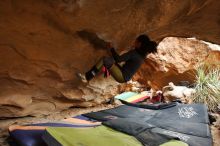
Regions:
[[136, 34, 157, 57]]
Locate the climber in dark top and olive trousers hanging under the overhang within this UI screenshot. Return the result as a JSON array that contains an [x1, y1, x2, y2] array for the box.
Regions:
[[77, 34, 157, 83]]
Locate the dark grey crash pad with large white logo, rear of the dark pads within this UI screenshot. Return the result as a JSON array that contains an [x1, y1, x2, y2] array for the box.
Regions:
[[83, 104, 209, 124]]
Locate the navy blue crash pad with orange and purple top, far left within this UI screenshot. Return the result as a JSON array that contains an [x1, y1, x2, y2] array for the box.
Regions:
[[9, 115, 101, 146]]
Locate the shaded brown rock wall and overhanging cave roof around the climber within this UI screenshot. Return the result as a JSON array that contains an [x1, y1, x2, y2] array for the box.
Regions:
[[0, 0, 220, 117]]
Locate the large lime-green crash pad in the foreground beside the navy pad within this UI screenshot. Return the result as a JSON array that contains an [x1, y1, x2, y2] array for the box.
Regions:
[[43, 126, 142, 146]]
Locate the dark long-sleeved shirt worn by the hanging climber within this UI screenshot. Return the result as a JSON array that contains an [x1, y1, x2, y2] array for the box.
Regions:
[[111, 48, 144, 81]]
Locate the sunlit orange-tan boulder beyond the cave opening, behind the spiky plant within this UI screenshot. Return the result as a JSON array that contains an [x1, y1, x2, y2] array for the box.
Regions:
[[134, 37, 220, 89]]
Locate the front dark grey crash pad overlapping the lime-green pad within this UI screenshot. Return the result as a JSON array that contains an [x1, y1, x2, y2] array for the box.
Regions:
[[103, 118, 212, 146]]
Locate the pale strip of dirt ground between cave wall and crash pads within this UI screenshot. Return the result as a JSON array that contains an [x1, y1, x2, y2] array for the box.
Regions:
[[0, 105, 220, 146]]
